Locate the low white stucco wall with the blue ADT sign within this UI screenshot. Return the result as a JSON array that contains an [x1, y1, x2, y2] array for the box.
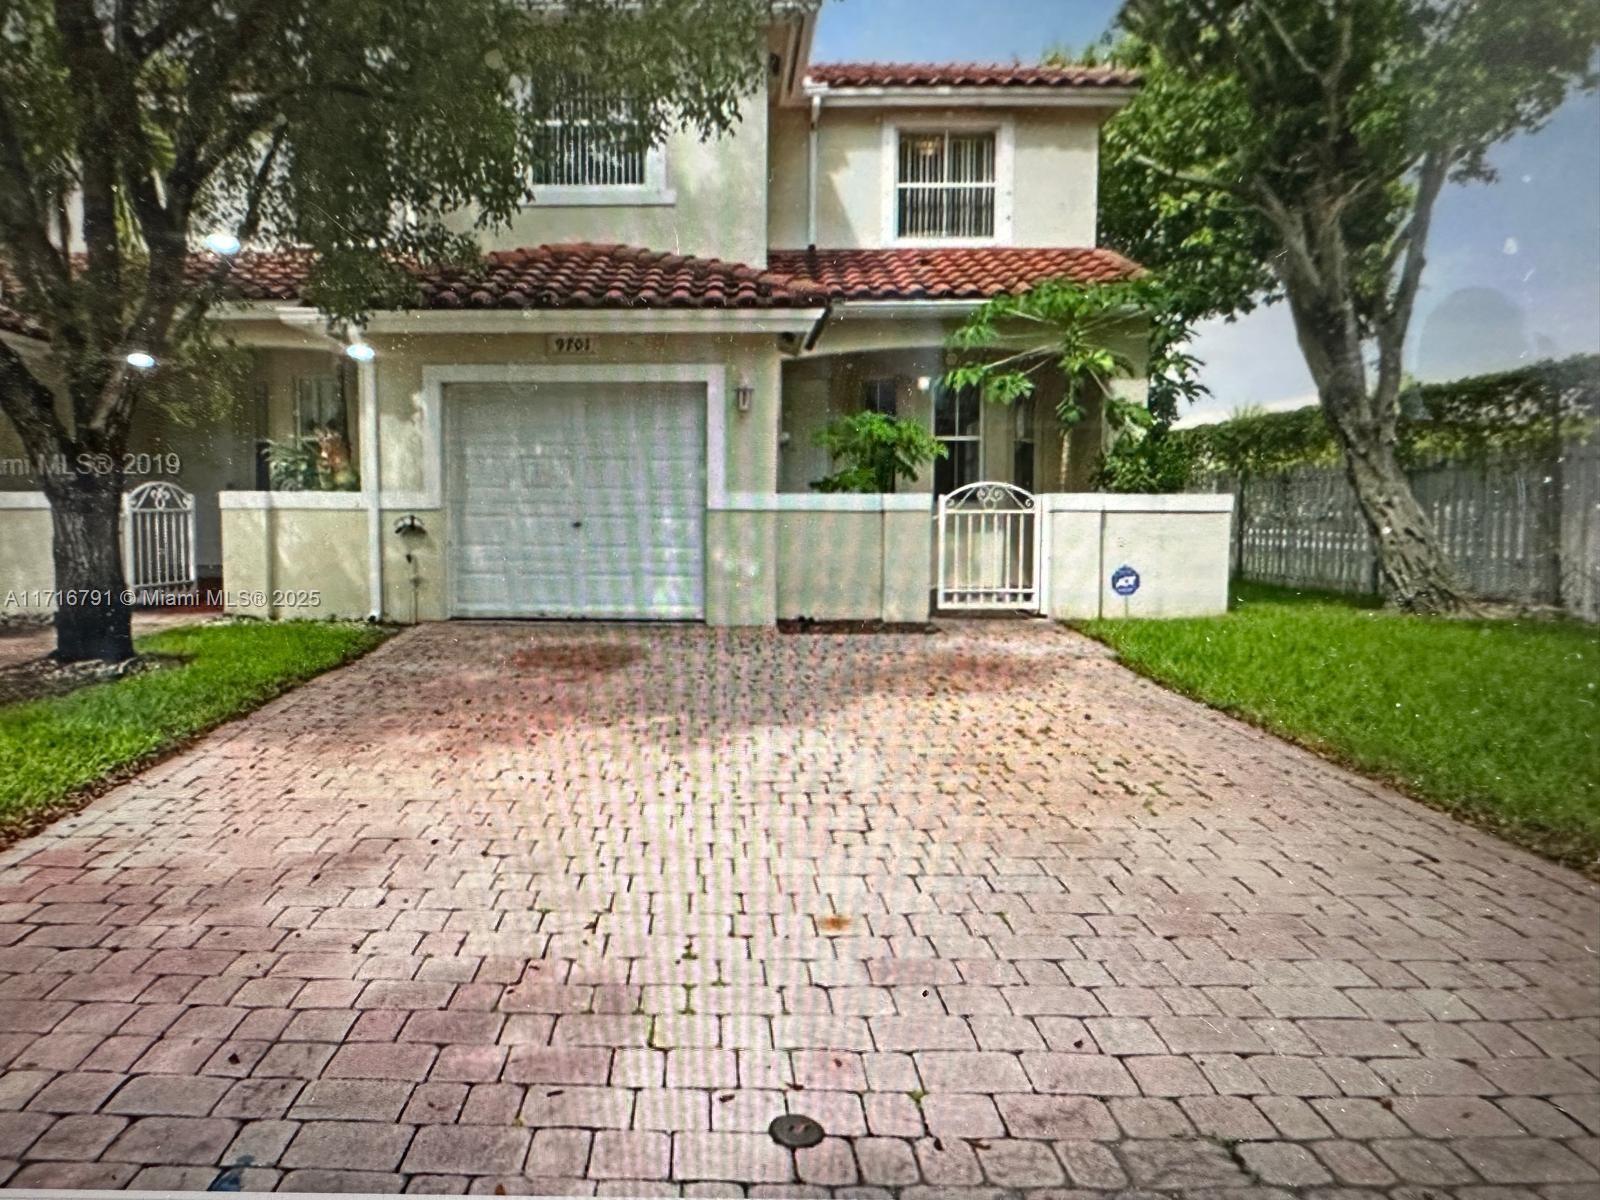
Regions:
[[1038, 493, 1234, 619]]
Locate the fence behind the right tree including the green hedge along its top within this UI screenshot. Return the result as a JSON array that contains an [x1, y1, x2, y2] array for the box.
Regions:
[[1171, 355, 1600, 621]]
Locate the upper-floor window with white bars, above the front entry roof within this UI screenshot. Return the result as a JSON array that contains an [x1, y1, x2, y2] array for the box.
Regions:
[[894, 130, 998, 242]]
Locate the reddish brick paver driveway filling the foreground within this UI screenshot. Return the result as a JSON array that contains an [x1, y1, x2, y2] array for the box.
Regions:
[[0, 622, 1600, 1200]]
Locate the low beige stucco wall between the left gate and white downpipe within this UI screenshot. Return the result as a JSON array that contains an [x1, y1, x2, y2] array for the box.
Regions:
[[222, 509, 370, 619]]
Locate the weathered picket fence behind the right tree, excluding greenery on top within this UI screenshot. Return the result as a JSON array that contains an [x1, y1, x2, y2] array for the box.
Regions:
[[1200, 442, 1600, 621]]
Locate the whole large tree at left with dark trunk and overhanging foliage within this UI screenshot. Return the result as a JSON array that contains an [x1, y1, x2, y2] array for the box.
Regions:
[[0, 0, 773, 661]]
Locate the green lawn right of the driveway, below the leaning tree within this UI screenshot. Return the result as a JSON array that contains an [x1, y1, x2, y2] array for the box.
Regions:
[[1080, 584, 1600, 872]]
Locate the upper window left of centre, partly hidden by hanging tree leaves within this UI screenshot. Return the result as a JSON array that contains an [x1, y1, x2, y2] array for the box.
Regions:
[[530, 86, 672, 205]]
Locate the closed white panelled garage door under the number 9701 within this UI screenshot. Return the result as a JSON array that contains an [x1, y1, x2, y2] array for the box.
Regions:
[[445, 384, 706, 619]]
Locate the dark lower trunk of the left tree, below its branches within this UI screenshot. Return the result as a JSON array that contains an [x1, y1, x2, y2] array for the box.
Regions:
[[45, 474, 133, 662]]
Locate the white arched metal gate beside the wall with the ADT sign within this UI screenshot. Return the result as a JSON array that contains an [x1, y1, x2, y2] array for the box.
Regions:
[[936, 483, 1043, 613]]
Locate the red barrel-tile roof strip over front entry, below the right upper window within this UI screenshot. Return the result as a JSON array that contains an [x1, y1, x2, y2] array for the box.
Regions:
[[771, 246, 1141, 301]]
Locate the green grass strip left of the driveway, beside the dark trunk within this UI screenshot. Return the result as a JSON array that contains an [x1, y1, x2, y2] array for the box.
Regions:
[[0, 621, 390, 842]]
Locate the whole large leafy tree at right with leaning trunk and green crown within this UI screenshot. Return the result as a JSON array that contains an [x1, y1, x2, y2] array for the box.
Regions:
[[1104, 0, 1600, 611]]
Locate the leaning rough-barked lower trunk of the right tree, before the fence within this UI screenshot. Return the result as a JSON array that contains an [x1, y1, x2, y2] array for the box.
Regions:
[[1331, 421, 1467, 613]]
